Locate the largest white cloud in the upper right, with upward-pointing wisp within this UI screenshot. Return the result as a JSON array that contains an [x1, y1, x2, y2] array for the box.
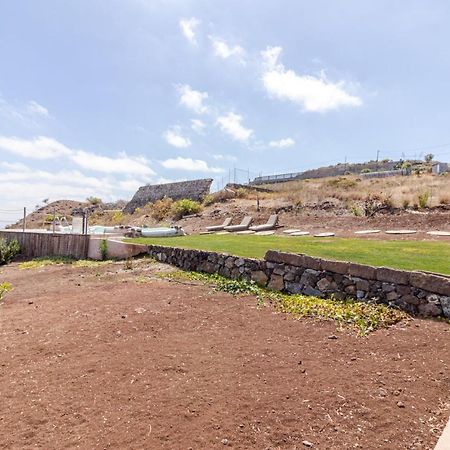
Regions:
[[261, 47, 362, 112]]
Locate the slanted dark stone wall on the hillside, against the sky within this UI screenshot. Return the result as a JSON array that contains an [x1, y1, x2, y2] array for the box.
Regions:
[[123, 178, 213, 214]]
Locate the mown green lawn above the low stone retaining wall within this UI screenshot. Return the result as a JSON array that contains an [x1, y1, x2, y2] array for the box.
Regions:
[[127, 235, 450, 275]]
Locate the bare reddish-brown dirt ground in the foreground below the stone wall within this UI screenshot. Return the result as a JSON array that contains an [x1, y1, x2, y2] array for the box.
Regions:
[[0, 259, 450, 450]]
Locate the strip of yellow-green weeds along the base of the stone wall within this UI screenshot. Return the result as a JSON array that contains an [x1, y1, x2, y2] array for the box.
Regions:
[[159, 271, 408, 335]]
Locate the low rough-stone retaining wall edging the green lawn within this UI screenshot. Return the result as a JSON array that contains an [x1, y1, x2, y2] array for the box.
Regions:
[[148, 245, 450, 318]]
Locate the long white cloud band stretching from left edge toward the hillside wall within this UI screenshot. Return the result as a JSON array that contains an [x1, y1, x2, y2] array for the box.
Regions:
[[0, 136, 155, 176]]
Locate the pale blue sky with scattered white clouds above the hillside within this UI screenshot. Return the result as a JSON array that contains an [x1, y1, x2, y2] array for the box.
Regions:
[[0, 0, 450, 220]]
